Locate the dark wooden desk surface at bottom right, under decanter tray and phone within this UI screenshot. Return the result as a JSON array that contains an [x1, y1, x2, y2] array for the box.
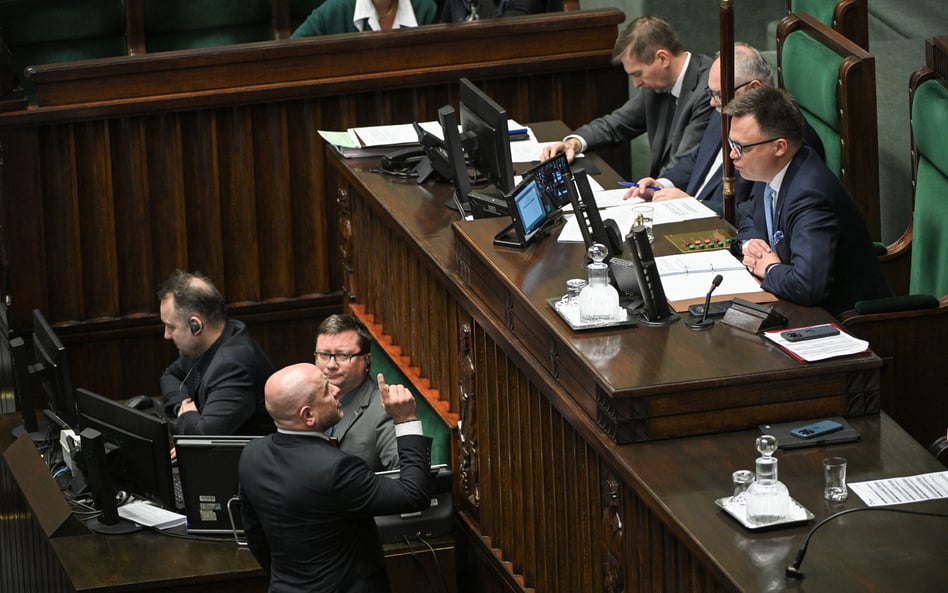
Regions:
[[616, 414, 948, 593]]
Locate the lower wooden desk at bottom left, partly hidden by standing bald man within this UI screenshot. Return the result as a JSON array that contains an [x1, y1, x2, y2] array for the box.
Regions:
[[0, 414, 457, 593]]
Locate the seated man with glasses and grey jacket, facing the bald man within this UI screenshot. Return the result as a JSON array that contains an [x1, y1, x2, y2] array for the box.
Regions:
[[313, 315, 398, 471]]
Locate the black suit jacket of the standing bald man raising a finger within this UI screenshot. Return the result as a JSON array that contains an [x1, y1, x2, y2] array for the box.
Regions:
[[240, 432, 431, 593]]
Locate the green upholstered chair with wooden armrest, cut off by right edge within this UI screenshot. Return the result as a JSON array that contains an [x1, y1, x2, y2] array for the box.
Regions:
[[840, 68, 948, 446]]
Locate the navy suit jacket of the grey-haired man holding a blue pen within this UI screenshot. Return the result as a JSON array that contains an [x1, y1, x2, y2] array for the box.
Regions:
[[662, 110, 825, 220]]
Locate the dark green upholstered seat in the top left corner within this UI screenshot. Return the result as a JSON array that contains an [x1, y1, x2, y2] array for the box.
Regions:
[[0, 0, 127, 95]]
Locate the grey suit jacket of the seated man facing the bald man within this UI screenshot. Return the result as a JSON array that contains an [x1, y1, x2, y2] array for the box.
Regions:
[[332, 375, 398, 472]]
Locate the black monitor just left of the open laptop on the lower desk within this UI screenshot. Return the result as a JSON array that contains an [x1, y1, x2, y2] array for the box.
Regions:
[[76, 389, 176, 509]]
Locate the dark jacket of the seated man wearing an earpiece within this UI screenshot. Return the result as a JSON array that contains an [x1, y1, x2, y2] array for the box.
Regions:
[[161, 320, 274, 435]]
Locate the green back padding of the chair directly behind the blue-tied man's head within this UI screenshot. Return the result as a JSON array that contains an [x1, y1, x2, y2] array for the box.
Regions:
[[781, 31, 842, 177]]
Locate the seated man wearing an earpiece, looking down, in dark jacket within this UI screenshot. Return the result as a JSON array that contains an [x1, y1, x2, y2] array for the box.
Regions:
[[158, 270, 275, 435]]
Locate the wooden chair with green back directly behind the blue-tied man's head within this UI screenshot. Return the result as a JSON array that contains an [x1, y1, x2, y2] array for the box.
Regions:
[[777, 13, 881, 240]]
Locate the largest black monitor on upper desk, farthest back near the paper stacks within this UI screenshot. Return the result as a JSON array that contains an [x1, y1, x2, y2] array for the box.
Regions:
[[460, 78, 514, 194]]
